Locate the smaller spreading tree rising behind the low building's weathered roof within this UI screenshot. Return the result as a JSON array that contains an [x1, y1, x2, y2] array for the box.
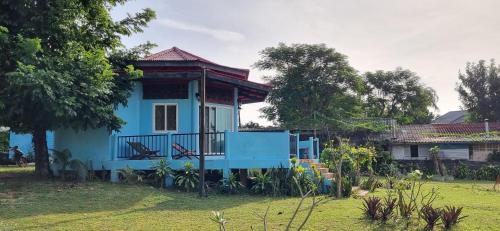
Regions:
[[365, 68, 437, 124]]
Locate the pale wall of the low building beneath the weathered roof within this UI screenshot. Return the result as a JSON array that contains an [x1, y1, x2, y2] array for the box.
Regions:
[[391, 144, 469, 160]]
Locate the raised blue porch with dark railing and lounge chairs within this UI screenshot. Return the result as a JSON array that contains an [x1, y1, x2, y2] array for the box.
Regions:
[[104, 131, 319, 181]]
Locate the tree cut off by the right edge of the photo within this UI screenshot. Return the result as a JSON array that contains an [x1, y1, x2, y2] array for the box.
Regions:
[[457, 60, 500, 122]]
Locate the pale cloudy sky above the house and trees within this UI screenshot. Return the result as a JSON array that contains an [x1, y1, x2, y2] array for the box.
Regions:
[[113, 0, 500, 124]]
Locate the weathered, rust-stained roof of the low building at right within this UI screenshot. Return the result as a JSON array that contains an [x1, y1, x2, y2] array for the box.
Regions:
[[383, 122, 500, 143]]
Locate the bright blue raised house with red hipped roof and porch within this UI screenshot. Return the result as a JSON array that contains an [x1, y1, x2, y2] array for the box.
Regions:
[[49, 47, 319, 181]]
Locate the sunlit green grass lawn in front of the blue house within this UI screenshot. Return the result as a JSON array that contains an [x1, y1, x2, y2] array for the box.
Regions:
[[0, 167, 500, 230]]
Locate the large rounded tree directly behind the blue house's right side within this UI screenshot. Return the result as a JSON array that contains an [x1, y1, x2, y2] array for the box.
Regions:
[[255, 43, 362, 128]]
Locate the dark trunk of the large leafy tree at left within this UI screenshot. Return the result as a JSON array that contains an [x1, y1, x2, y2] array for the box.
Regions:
[[33, 128, 50, 179]]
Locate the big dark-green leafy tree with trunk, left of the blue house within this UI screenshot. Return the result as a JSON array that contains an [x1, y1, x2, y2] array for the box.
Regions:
[[0, 0, 155, 177]]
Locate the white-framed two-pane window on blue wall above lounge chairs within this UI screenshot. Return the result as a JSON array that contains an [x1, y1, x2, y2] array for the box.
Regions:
[[153, 104, 177, 132]]
